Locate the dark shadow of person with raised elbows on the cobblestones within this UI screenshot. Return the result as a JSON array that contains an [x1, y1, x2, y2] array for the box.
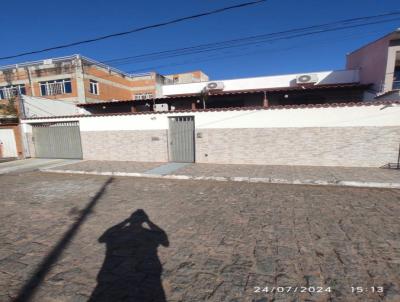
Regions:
[[89, 210, 169, 302]]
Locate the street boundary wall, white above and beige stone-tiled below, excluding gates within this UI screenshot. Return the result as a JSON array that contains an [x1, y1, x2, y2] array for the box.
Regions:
[[23, 104, 400, 167]]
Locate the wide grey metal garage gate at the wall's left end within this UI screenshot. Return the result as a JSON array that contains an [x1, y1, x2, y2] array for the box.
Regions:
[[32, 122, 82, 159]]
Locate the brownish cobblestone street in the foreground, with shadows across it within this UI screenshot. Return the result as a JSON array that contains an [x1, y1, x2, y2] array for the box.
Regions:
[[0, 172, 400, 302]]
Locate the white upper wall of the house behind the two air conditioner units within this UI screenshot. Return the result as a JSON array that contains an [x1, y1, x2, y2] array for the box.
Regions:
[[162, 70, 359, 96]]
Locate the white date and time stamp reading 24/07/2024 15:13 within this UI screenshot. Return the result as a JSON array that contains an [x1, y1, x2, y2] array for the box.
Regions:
[[254, 286, 384, 294]]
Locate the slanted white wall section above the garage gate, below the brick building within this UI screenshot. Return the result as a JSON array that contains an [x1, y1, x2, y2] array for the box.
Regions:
[[22, 95, 88, 117]]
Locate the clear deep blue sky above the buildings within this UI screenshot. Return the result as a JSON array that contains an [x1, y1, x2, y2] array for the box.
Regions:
[[0, 0, 400, 79]]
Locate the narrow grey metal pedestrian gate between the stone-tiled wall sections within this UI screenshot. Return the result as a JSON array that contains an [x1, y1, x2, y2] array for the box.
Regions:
[[168, 116, 195, 163]]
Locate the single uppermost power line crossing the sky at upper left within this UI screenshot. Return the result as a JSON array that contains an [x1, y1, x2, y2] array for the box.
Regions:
[[0, 0, 267, 60]]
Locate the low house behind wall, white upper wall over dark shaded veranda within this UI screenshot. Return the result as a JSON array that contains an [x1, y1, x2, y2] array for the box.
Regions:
[[78, 70, 369, 114]]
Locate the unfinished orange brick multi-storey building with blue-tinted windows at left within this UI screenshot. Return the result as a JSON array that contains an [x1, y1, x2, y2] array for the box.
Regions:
[[0, 55, 208, 108]]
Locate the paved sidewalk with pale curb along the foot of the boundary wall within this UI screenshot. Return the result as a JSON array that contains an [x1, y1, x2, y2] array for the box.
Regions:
[[42, 161, 400, 189]]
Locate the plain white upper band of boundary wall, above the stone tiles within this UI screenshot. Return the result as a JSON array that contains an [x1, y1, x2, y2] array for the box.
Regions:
[[22, 104, 400, 132]]
